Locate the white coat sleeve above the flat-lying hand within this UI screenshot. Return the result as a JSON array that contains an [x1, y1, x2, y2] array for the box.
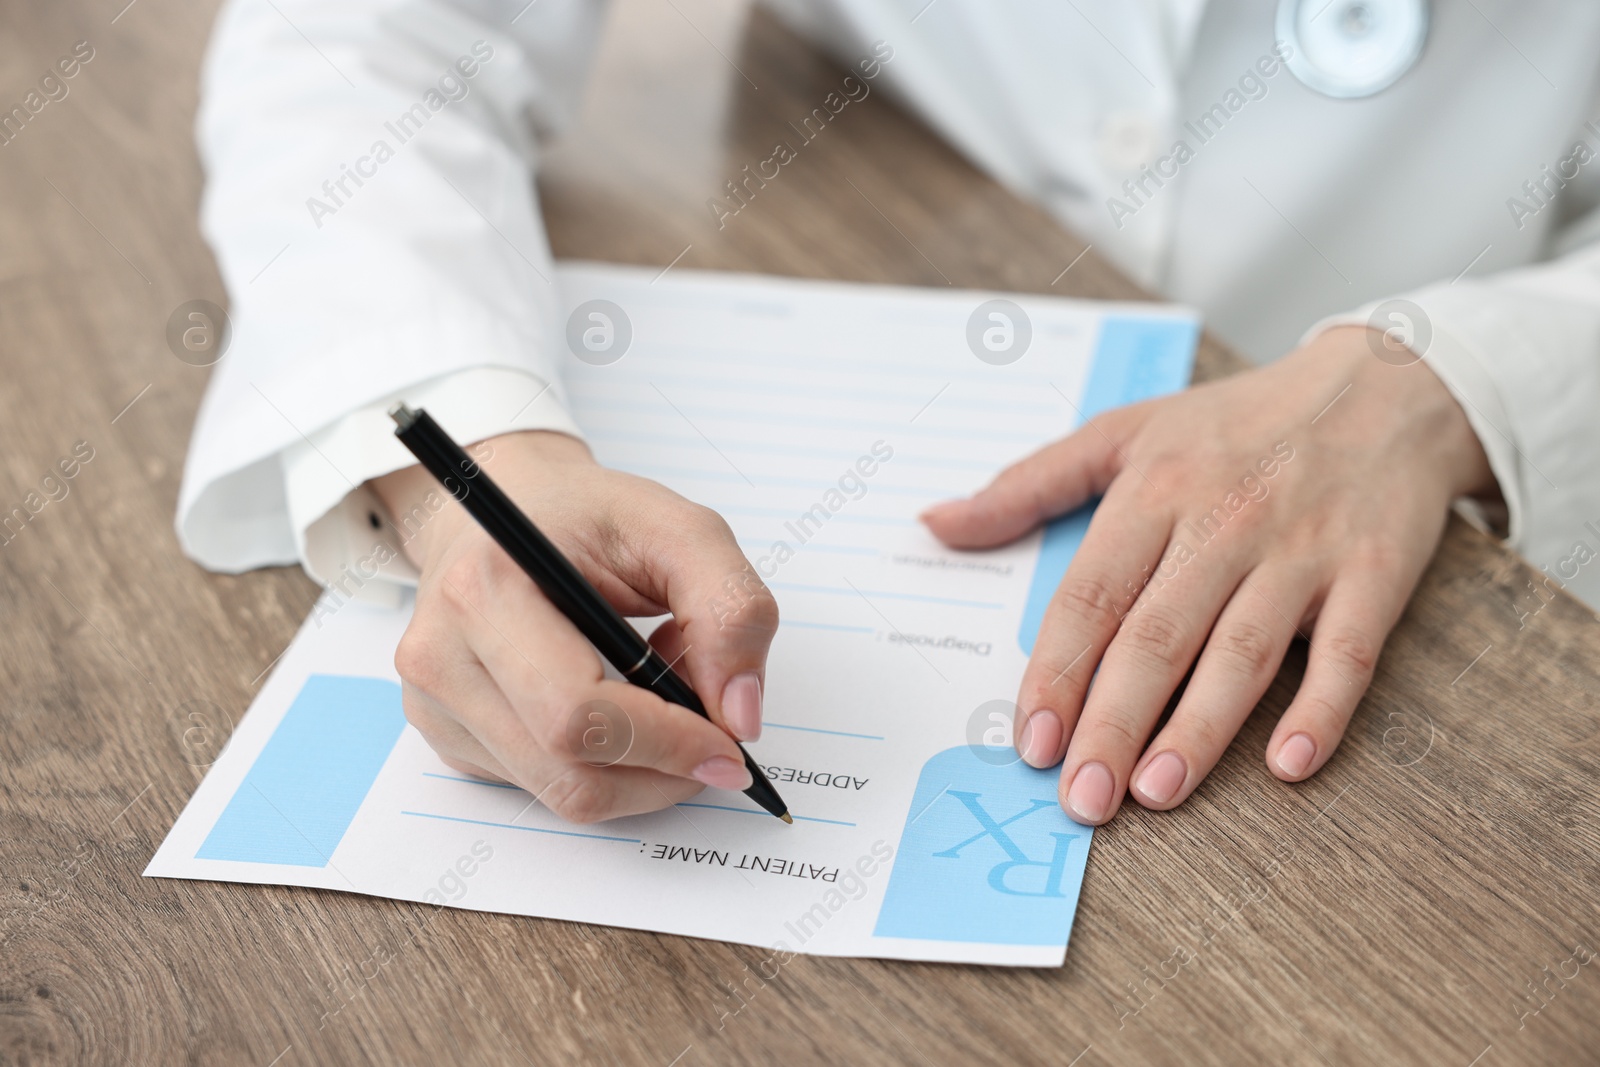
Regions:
[[1306, 233, 1600, 611]]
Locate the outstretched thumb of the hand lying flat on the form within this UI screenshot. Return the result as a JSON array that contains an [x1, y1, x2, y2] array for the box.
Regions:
[[920, 422, 1123, 549]]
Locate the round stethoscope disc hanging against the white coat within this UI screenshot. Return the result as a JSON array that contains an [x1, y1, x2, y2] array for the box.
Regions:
[[1277, 0, 1427, 99]]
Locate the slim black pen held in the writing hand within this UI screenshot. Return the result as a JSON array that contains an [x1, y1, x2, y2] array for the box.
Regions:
[[389, 403, 794, 824]]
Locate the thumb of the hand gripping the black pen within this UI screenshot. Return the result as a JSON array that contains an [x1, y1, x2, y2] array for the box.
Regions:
[[630, 506, 778, 741]]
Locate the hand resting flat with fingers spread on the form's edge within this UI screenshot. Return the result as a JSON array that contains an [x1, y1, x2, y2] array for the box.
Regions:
[[923, 326, 1496, 824]]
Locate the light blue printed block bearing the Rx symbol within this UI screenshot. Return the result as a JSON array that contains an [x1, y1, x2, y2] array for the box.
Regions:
[[874, 745, 1093, 945]]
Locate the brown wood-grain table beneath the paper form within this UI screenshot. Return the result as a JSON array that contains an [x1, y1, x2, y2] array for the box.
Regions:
[[0, 0, 1600, 1067]]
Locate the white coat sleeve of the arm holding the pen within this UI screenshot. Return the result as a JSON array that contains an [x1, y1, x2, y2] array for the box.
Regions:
[[178, 0, 605, 582]]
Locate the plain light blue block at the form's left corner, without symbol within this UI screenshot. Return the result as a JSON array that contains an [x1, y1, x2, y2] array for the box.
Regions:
[[195, 675, 405, 867]]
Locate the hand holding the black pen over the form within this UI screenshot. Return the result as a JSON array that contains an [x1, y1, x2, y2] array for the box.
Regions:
[[371, 432, 778, 822]]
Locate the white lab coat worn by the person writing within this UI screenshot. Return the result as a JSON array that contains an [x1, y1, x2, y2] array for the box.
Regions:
[[178, 0, 1600, 611]]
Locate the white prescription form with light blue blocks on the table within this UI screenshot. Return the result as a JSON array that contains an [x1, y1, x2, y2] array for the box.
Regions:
[[146, 264, 1198, 966]]
